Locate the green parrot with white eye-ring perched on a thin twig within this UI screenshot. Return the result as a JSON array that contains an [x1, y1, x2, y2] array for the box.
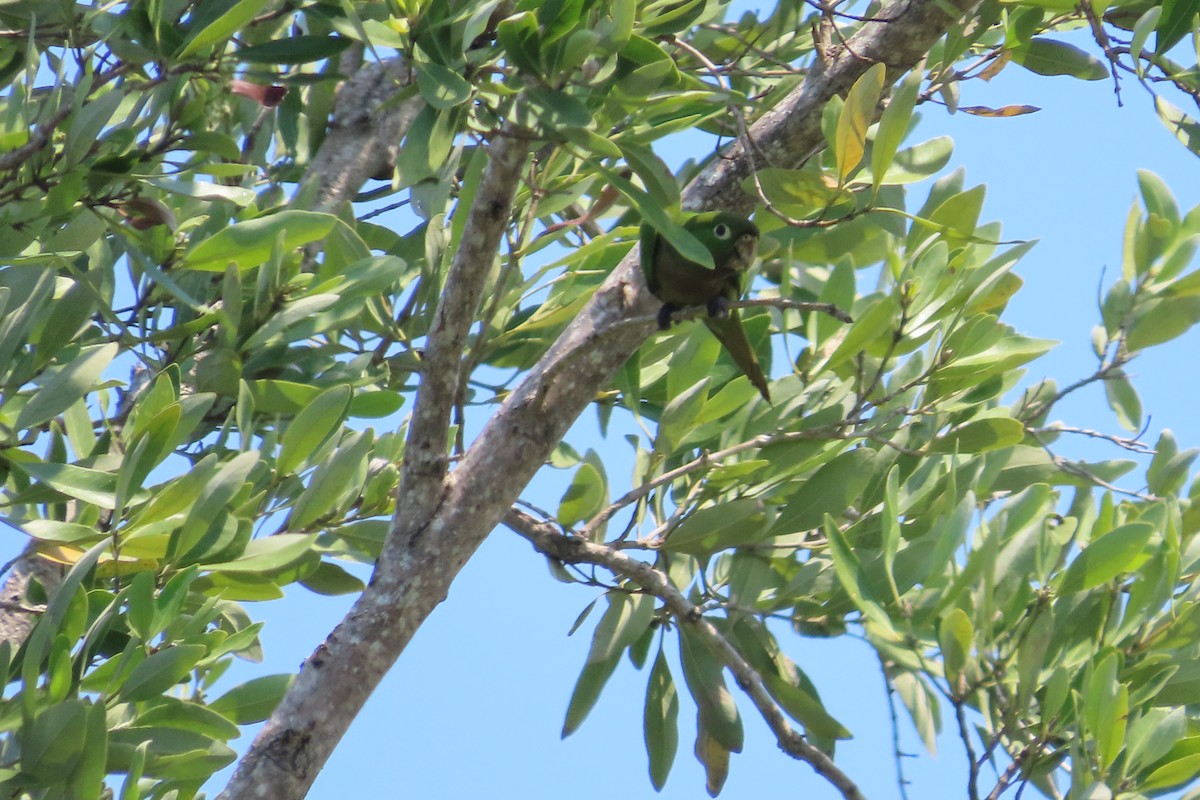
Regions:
[[641, 211, 770, 403]]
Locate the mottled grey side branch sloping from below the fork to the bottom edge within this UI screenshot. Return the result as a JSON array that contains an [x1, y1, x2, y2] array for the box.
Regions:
[[504, 509, 863, 800]]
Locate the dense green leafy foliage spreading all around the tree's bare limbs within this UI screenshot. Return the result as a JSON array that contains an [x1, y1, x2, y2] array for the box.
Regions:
[[0, 0, 1200, 798]]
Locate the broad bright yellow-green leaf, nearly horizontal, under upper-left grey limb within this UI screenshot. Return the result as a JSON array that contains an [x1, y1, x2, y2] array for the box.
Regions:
[[180, 211, 338, 272]]
